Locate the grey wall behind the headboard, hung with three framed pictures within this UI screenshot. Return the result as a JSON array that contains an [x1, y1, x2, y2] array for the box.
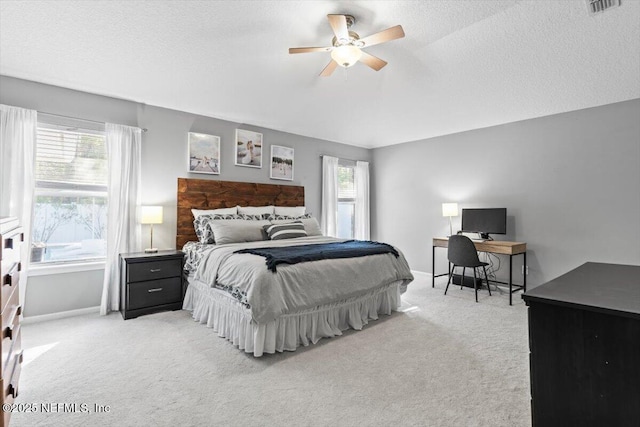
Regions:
[[0, 76, 371, 317]]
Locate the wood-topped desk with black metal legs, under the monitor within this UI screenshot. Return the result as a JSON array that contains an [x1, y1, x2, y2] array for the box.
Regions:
[[431, 237, 527, 305]]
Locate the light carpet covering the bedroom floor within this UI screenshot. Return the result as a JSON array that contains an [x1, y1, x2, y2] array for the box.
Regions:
[[11, 274, 531, 427]]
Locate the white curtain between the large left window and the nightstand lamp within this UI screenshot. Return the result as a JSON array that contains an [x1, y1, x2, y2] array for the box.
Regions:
[[100, 123, 142, 315]]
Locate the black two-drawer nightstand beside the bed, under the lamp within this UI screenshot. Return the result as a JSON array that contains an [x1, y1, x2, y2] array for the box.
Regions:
[[120, 250, 184, 320]]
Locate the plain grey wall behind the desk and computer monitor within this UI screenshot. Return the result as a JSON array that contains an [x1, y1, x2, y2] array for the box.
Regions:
[[372, 99, 640, 286]]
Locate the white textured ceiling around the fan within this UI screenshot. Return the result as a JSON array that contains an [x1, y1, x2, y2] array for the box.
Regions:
[[0, 0, 640, 147]]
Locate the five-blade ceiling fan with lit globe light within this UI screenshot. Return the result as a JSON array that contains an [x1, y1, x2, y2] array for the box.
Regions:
[[289, 15, 404, 77]]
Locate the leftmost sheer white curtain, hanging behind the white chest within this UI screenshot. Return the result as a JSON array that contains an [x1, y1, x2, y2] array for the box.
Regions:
[[0, 104, 38, 307]]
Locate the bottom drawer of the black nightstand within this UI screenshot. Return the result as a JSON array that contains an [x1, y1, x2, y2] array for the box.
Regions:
[[127, 277, 182, 310]]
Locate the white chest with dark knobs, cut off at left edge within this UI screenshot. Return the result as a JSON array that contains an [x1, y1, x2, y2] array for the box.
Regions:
[[0, 217, 24, 427]]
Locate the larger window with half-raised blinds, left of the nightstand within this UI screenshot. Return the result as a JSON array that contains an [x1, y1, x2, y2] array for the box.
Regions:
[[31, 122, 107, 263]]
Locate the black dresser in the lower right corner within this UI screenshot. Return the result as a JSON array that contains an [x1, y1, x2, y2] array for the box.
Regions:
[[522, 262, 640, 427]]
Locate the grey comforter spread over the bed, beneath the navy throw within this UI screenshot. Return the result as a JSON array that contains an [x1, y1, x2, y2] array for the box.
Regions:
[[189, 236, 413, 324]]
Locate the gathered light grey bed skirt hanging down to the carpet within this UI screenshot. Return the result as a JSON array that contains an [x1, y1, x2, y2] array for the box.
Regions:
[[183, 280, 402, 357]]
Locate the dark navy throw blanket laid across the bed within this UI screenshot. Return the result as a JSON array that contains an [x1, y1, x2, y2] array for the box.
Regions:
[[234, 240, 400, 272]]
